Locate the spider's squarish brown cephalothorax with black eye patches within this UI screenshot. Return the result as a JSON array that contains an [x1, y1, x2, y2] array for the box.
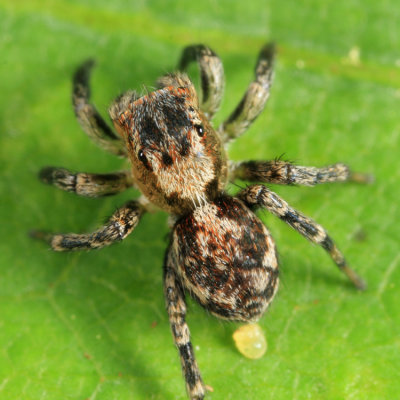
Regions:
[[110, 74, 227, 214]]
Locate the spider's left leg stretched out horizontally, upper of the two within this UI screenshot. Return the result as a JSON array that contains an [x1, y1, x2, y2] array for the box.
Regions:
[[39, 167, 133, 197]]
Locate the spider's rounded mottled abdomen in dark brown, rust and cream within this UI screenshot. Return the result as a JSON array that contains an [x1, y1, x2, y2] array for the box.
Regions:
[[169, 196, 278, 321]]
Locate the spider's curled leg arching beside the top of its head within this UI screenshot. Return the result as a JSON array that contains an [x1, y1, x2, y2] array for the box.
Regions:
[[178, 44, 225, 120]]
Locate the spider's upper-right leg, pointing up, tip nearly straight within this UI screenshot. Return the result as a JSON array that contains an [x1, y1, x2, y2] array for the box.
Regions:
[[219, 43, 275, 142]]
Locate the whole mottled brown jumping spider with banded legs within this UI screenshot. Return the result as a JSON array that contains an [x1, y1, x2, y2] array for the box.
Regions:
[[33, 44, 368, 399]]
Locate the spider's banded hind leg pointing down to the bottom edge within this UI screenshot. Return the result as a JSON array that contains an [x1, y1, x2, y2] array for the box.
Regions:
[[164, 254, 205, 400]]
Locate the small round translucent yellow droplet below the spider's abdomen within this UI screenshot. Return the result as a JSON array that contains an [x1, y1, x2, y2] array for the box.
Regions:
[[232, 324, 267, 359]]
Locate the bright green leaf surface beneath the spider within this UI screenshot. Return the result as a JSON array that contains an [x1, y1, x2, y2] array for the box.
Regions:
[[0, 0, 400, 400]]
